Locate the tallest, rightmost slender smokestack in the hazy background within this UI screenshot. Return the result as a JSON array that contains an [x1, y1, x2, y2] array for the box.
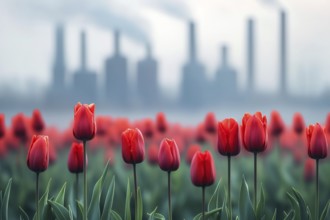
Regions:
[[280, 10, 287, 95]]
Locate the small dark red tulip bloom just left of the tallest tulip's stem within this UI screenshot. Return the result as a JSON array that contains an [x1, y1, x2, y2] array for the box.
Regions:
[[68, 142, 84, 173]]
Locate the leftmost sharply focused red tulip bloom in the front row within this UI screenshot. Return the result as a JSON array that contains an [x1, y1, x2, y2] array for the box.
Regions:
[[27, 135, 49, 173]]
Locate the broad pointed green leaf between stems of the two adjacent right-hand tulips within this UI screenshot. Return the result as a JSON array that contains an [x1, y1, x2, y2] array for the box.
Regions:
[[239, 176, 255, 219]]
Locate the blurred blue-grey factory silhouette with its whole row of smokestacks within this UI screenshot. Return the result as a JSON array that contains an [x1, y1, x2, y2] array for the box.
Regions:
[[43, 10, 312, 109]]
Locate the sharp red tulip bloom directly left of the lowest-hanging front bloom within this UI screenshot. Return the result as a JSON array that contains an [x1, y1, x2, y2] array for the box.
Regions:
[[158, 138, 180, 172]]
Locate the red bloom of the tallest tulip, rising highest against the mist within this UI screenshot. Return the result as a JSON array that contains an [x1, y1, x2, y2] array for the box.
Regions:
[[73, 102, 96, 141]]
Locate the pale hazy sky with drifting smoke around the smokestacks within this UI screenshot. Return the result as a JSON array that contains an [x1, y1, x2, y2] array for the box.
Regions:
[[0, 0, 330, 94]]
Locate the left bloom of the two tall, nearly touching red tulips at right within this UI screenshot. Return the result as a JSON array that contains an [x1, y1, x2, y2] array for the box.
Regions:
[[218, 118, 240, 156]]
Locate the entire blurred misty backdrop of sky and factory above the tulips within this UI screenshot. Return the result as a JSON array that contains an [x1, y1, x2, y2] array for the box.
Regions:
[[0, 0, 330, 126]]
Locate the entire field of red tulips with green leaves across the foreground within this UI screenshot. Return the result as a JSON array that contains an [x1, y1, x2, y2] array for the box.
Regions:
[[0, 103, 330, 220]]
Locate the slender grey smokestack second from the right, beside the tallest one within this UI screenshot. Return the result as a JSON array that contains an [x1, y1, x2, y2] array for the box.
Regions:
[[247, 18, 255, 92]]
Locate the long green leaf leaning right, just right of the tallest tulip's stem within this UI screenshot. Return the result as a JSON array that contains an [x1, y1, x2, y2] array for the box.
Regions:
[[88, 162, 109, 219]]
